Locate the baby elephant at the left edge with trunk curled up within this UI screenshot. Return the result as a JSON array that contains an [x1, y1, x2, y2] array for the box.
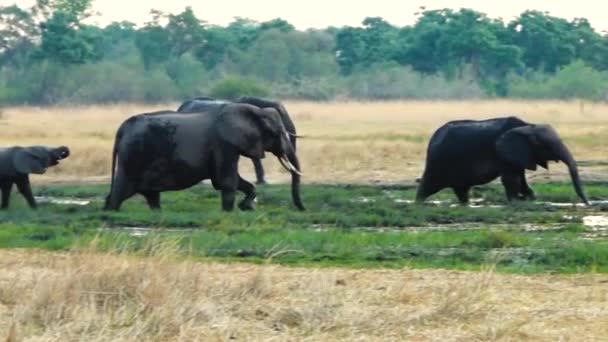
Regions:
[[0, 146, 70, 209]]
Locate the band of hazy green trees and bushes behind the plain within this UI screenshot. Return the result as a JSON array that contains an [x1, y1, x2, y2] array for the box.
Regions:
[[0, 0, 608, 104]]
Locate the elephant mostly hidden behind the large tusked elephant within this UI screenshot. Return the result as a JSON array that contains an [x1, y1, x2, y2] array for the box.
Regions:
[[177, 96, 297, 184]]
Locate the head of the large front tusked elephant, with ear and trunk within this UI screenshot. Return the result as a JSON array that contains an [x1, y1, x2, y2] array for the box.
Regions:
[[218, 104, 305, 210]]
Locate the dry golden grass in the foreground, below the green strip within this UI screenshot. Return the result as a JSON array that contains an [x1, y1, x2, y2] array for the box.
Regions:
[[0, 243, 608, 341]]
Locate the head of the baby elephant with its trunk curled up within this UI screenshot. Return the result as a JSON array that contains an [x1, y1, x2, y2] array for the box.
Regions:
[[13, 146, 70, 174]]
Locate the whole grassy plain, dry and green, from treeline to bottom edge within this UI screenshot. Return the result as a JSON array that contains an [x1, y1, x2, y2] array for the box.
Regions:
[[0, 100, 608, 341]]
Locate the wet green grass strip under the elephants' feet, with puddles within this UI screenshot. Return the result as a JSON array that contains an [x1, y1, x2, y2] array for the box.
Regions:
[[0, 183, 608, 273]]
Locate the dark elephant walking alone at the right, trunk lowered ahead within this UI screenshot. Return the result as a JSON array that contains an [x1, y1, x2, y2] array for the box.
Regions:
[[416, 116, 589, 204]]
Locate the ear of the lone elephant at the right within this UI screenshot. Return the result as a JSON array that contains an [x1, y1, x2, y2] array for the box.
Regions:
[[496, 126, 547, 171]]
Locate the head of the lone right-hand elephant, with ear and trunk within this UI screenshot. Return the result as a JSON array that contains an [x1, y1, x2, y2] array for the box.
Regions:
[[496, 125, 589, 204]]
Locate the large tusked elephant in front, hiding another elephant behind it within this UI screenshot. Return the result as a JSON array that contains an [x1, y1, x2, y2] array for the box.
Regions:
[[104, 103, 305, 211]]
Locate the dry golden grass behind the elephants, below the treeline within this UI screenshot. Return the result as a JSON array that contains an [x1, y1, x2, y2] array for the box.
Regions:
[[0, 100, 608, 183]]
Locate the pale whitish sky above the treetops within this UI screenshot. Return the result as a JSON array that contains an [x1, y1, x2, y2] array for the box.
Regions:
[[0, 0, 608, 31]]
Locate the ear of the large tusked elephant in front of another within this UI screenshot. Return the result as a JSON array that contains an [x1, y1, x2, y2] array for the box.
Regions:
[[217, 104, 265, 159]]
